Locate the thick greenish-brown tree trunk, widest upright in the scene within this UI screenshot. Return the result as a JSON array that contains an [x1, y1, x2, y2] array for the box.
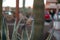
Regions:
[[33, 0, 44, 40]]
